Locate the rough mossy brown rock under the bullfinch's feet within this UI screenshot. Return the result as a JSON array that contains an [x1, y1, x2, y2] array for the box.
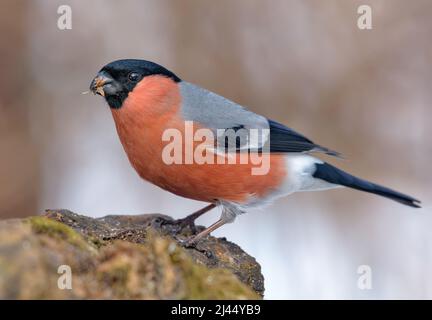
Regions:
[[0, 210, 264, 299]]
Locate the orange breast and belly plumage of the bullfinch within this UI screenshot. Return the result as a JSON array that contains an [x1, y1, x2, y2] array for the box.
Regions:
[[111, 75, 286, 203]]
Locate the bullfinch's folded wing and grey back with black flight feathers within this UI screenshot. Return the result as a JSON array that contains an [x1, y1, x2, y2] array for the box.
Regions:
[[179, 81, 339, 156]]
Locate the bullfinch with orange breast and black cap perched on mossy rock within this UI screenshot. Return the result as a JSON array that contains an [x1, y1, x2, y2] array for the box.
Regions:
[[90, 59, 420, 244]]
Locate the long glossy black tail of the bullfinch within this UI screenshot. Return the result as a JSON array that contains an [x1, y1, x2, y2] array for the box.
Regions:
[[313, 163, 420, 208]]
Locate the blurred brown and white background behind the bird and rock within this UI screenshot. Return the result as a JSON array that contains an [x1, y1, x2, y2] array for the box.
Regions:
[[0, 0, 432, 299]]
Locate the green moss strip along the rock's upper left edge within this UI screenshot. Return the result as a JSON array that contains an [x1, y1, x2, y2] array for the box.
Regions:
[[27, 217, 89, 249]]
